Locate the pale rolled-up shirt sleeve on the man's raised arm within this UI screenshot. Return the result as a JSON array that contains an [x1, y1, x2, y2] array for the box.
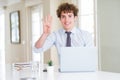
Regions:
[[33, 33, 56, 53]]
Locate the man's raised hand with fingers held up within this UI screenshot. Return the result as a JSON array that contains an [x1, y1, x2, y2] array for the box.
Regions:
[[43, 15, 52, 34]]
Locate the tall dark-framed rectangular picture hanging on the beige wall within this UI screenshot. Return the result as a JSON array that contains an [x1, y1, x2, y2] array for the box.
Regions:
[[10, 11, 21, 44]]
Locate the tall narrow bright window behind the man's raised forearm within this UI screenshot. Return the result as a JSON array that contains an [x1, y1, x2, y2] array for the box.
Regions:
[[31, 6, 43, 63]]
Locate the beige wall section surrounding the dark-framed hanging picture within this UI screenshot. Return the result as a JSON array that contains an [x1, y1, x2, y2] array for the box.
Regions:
[[5, 2, 26, 63]]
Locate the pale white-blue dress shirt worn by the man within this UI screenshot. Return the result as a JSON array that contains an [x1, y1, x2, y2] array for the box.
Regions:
[[34, 27, 94, 53]]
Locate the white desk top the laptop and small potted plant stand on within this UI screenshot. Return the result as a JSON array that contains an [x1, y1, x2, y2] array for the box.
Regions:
[[6, 63, 120, 80]]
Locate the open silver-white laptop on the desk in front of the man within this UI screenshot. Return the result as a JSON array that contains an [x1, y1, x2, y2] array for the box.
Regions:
[[60, 47, 98, 72]]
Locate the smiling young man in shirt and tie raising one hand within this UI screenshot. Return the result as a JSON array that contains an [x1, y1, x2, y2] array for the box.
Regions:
[[35, 3, 94, 53]]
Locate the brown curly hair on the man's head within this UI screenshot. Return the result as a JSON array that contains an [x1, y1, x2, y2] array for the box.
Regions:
[[56, 3, 79, 18]]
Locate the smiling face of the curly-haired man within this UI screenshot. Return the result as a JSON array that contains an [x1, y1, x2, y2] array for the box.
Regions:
[[60, 12, 76, 31]]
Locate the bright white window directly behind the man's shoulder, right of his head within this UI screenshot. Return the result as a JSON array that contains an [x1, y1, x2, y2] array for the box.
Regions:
[[78, 0, 96, 44]]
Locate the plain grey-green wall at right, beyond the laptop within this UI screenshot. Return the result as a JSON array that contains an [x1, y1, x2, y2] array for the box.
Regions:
[[97, 0, 120, 72]]
